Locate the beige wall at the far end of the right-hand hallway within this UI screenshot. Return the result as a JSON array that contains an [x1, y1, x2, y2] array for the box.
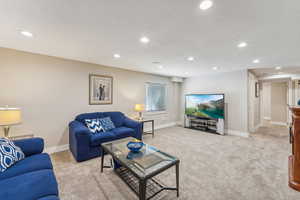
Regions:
[[271, 82, 288, 123]]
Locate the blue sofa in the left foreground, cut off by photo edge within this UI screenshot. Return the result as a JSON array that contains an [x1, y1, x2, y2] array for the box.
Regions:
[[0, 138, 59, 200]]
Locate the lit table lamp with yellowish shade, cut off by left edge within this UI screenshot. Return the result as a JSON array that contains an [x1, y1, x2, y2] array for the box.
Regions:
[[0, 107, 21, 137]]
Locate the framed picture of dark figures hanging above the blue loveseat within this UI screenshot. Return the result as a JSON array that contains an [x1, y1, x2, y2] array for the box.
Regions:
[[89, 74, 113, 105]]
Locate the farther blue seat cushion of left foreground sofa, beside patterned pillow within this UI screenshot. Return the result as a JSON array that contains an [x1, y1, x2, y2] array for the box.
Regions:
[[0, 153, 52, 180]]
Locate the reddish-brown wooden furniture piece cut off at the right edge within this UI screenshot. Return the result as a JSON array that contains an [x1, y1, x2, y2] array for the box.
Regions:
[[289, 106, 300, 192]]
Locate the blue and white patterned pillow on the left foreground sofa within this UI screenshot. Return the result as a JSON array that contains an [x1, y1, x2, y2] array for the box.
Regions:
[[0, 138, 25, 172]]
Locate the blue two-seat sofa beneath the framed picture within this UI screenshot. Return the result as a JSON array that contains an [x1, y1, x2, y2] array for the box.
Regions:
[[69, 112, 142, 162]]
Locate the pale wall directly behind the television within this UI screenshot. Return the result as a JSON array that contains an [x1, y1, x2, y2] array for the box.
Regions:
[[181, 70, 248, 135]]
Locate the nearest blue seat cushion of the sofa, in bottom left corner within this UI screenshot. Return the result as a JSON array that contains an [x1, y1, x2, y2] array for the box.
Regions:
[[0, 169, 58, 200]]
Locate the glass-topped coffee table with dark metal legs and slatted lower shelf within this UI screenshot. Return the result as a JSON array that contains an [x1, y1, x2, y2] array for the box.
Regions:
[[101, 137, 180, 200]]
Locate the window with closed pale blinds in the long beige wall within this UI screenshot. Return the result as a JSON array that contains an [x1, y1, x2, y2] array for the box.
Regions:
[[146, 83, 166, 112]]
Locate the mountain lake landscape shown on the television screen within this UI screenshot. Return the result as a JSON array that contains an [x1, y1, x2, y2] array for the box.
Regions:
[[185, 94, 224, 119]]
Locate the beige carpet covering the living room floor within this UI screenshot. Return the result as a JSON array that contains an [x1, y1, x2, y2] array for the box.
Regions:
[[51, 127, 300, 200]]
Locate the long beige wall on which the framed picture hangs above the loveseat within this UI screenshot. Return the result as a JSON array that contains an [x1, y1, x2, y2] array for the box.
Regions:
[[0, 48, 180, 147]]
